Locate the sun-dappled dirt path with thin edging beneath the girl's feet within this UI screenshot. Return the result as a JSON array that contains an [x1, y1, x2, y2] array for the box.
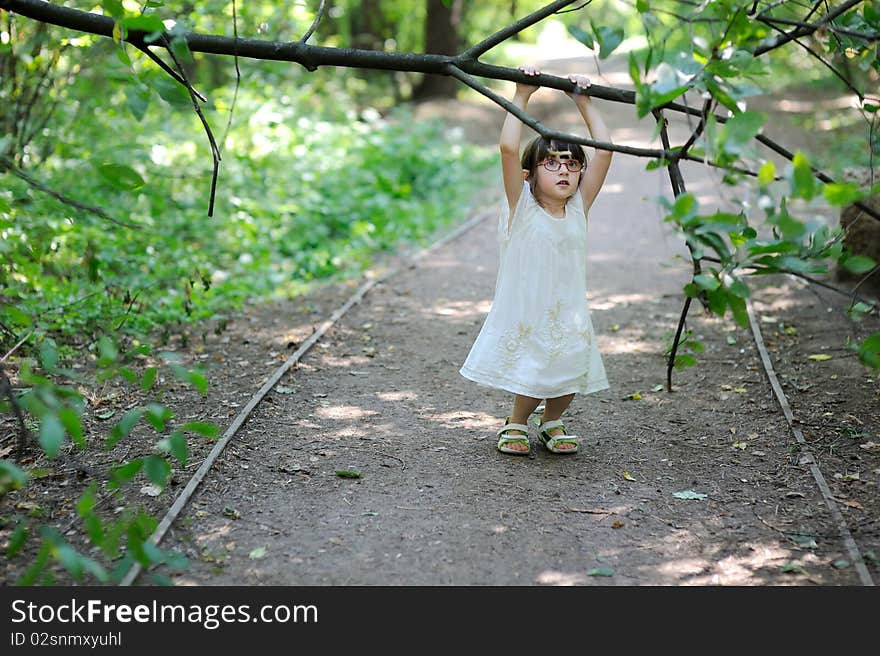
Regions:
[[148, 59, 880, 585]]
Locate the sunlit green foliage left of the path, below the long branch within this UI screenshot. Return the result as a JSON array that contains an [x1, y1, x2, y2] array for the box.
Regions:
[[0, 2, 492, 585]]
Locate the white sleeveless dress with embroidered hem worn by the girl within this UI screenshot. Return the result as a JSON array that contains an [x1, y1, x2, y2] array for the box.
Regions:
[[461, 182, 608, 399]]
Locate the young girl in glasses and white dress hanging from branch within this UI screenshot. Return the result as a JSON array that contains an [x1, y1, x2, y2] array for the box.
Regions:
[[461, 66, 611, 455]]
